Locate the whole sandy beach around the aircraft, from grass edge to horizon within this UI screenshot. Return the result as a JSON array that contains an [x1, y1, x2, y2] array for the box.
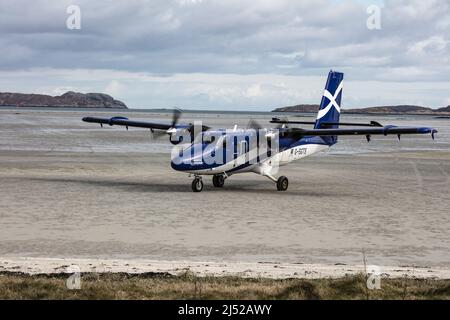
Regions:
[[0, 110, 450, 278]]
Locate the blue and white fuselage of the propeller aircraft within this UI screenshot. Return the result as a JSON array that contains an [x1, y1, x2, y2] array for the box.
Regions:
[[171, 129, 334, 177]]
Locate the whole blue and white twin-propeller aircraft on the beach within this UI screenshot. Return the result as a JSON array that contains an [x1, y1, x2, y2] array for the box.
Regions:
[[83, 71, 437, 192]]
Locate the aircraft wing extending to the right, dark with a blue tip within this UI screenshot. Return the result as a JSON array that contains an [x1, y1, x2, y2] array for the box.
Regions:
[[286, 125, 437, 139]]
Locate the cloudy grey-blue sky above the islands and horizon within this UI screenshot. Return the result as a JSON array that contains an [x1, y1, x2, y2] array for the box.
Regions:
[[0, 0, 450, 111]]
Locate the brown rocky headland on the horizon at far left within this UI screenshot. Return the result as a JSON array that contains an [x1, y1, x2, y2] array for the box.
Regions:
[[0, 91, 128, 109]]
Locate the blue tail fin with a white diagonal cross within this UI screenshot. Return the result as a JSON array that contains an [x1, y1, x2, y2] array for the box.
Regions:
[[314, 70, 344, 144]]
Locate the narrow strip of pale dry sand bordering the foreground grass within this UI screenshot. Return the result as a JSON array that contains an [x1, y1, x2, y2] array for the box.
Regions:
[[0, 258, 450, 280]]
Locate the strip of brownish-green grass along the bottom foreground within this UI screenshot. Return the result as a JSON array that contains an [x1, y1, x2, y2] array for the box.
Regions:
[[0, 272, 450, 300]]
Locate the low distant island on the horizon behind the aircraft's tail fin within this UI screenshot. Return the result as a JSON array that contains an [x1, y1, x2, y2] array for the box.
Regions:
[[272, 104, 450, 116]]
